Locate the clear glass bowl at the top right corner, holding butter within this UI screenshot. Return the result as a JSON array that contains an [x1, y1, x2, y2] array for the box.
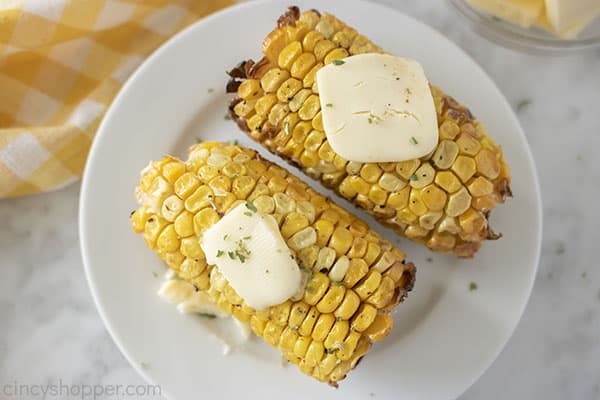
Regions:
[[448, 0, 600, 55]]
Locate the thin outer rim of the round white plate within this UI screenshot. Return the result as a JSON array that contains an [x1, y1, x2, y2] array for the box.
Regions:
[[78, 0, 543, 398]]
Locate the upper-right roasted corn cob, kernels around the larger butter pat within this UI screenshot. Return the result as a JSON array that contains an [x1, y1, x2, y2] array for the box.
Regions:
[[227, 7, 511, 257]]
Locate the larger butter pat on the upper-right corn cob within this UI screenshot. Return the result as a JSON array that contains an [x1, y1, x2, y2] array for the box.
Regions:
[[317, 54, 438, 162]]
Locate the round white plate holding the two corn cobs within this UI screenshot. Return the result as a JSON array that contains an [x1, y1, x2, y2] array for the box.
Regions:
[[80, 0, 541, 400]]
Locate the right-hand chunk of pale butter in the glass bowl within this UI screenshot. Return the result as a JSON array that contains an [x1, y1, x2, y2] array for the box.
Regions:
[[545, 0, 600, 37]]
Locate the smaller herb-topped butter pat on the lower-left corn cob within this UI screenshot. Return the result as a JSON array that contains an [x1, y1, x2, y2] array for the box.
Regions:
[[201, 203, 302, 310]]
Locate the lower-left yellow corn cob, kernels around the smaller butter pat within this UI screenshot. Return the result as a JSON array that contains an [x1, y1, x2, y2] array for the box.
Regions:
[[131, 142, 415, 385]]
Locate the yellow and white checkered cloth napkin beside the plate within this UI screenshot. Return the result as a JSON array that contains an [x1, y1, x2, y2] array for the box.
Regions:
[[0, 0, 233, 198]]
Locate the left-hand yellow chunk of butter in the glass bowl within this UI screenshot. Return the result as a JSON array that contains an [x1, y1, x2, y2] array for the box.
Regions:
[[467, 0, 544, 28]]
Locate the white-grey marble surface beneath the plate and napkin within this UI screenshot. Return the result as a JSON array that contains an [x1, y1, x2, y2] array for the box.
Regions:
[[0, 0, 600, 400]]
